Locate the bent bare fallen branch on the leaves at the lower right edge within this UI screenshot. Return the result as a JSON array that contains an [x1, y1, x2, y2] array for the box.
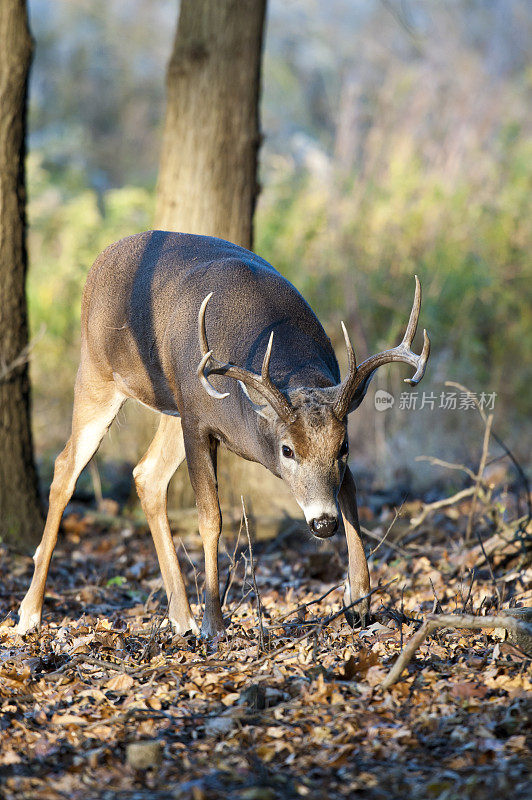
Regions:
[[381, 614, 532, 689]]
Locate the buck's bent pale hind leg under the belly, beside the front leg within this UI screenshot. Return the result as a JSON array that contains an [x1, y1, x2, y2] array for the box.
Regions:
[[133, 414, 199, 633]]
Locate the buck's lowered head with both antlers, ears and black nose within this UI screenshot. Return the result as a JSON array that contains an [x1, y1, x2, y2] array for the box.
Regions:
[[197, 276, 430, 539]]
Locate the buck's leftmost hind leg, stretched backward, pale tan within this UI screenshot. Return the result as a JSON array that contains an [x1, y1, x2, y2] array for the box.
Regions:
[[17, 367, 125, 634]]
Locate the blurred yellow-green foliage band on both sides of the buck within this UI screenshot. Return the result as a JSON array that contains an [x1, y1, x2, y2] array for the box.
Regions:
[[28, 126, 532, 462]]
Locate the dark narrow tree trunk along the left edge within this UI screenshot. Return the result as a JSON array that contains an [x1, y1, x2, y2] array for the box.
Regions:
[[0, 0, 42, 549]]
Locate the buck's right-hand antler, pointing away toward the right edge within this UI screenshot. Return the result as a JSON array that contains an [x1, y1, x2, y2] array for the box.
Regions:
[[334, 275, 430, 419]]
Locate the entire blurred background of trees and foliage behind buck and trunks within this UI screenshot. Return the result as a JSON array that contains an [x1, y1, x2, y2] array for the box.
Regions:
[[22, 0, 532, 506]]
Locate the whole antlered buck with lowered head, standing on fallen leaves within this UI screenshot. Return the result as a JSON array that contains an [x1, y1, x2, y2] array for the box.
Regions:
[[18, 231, 430, 636]]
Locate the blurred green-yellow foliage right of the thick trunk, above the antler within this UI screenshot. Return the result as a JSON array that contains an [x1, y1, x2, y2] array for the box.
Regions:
[[256, 132, 532, 414]]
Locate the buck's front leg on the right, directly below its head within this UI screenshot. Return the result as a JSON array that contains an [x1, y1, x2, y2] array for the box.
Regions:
[[338, 467, 370, 626]]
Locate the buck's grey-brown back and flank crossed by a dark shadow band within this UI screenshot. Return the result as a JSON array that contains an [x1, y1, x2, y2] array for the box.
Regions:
[[82, 231, 339, 412]]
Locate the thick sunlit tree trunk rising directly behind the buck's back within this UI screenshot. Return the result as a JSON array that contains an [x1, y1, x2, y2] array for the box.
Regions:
[[156, 0, 266, 248]]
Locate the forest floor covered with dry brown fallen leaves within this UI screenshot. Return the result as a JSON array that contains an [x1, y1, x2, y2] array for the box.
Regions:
[[0, 488, 532, 800]]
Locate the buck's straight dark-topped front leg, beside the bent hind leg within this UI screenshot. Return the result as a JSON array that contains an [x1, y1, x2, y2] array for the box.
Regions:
[[183, 430, 225, 637]]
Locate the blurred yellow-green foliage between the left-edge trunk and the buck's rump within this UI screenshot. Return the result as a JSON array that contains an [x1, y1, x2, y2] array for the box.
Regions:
[[27, 152, 154, 453]]
